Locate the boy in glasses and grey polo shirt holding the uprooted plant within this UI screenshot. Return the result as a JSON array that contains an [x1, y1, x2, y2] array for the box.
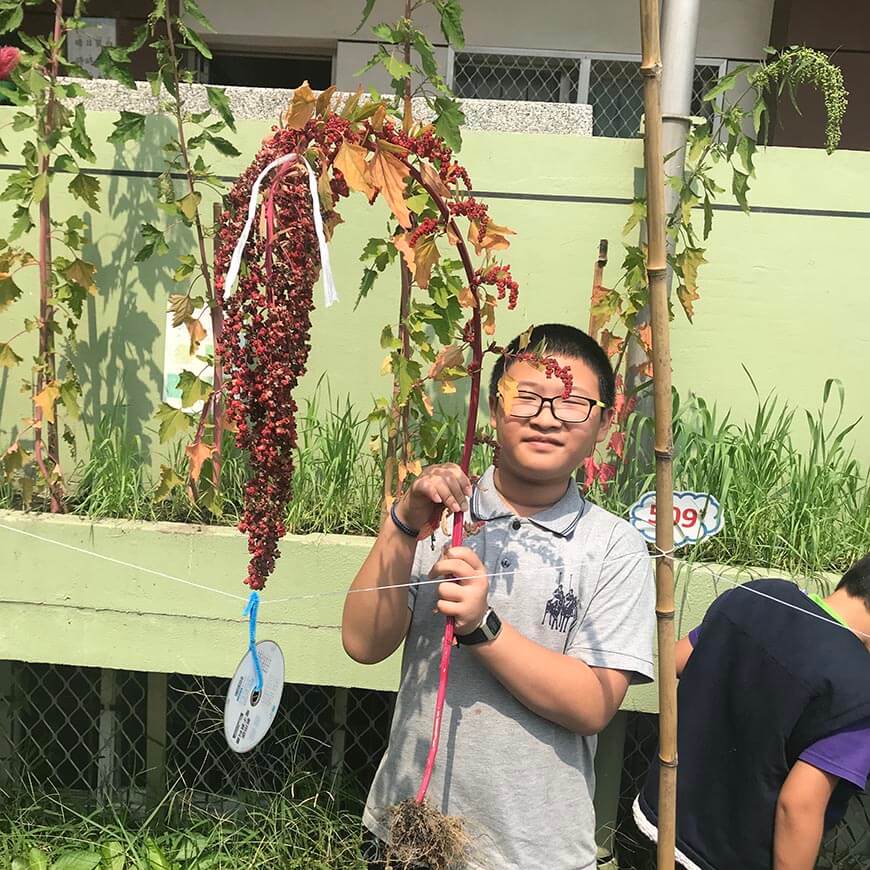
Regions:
[[342, 324, 654, 870]]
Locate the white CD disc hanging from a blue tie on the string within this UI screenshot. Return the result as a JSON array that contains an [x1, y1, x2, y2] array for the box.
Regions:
[[224, 640, 284, 753]]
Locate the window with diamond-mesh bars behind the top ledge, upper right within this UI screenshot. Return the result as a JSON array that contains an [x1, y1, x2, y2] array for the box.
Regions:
[[453, 50, 723, 138]]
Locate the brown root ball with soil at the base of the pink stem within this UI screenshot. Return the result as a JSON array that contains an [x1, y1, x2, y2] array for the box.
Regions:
[[386, 799, 470, 870]]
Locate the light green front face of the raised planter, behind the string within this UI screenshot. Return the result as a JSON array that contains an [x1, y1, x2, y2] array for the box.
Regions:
[[0, 511, 828, 712]]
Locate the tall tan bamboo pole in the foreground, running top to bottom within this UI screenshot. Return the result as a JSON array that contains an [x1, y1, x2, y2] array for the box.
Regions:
[[640, 0, 677, 870]]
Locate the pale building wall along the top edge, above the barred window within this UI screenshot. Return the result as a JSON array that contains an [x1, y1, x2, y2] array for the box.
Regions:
[[200, 0, 773, 58]]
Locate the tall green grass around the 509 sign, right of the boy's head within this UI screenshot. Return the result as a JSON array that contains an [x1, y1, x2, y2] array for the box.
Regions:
[[592, 373, 870, 574]]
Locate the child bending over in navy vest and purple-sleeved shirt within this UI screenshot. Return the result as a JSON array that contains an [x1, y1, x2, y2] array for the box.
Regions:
[[633, 555, 870, 870]]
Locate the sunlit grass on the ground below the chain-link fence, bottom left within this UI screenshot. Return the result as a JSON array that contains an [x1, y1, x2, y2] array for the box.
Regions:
[[0, 783, 365, 870]]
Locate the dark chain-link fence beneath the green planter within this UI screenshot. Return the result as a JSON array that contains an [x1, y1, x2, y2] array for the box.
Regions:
[[0, 661, 870, 870]]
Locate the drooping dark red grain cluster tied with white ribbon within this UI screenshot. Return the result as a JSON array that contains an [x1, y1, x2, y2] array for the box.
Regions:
[[215, 104, 517, 589]]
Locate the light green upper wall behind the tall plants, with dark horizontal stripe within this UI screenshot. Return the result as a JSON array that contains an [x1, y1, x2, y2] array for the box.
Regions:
[[0, 109, 870, 462]]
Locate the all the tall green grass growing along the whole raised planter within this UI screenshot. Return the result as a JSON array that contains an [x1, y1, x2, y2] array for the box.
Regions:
[[0, 379, 870, 574]]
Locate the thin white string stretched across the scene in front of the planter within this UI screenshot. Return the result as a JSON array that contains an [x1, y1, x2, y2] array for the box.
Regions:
[[0, 523, 870, 638]]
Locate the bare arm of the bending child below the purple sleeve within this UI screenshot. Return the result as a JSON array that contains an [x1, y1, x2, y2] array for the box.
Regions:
[[773, 761, 839, 870]]
